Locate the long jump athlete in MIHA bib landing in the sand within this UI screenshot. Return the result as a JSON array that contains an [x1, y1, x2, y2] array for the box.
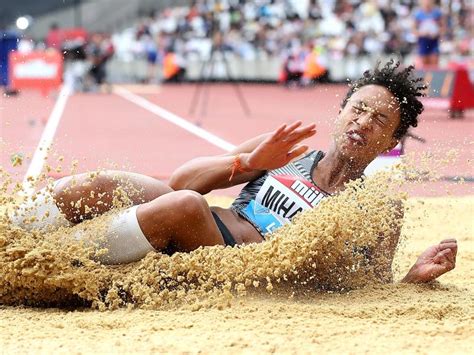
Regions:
[[10, 62, 457, 282]]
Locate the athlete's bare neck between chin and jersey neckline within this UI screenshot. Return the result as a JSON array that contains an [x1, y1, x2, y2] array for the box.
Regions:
[[313, 146, 367, 193]]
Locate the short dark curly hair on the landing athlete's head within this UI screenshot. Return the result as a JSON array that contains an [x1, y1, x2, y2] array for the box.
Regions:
[[341, 59, 426, 139]]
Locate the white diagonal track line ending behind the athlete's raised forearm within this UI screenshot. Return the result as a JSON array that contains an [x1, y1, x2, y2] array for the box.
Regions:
[[114, 86, 235, 152]]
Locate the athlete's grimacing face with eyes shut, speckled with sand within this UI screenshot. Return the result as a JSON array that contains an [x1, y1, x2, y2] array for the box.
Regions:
[[334, 85, 400, 163]]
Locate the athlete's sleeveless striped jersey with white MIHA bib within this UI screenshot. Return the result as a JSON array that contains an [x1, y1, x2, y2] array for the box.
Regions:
[[231, 151, 329, 236]]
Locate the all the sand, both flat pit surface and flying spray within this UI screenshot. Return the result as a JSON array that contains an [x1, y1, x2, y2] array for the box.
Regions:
[[0, 159, 474, 353]]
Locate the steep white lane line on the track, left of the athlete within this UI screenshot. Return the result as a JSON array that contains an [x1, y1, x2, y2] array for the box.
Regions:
[[22, 85, 71, 195]]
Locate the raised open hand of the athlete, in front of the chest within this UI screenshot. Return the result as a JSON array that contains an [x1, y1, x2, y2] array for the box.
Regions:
[[243, 121, 316, 170]]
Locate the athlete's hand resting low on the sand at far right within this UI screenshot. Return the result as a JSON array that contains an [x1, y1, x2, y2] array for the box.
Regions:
[[402, 239, 458, 283]]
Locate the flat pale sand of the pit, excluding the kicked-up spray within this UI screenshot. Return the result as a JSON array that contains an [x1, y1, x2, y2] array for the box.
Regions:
[[0, 192, 474, 354]]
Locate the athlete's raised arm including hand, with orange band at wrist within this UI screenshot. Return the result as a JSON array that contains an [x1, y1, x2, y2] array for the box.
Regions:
[[169, 121, 316, 194]]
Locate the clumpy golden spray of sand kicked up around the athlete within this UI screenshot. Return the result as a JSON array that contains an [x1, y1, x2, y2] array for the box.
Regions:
[[0, 168, 406, 310]]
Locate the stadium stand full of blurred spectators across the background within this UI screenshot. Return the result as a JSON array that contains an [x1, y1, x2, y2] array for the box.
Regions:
[[1, 0, 474, 83]]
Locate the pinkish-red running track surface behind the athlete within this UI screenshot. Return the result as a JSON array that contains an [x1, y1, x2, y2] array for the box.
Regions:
[[0, 84, 474, 196]]
